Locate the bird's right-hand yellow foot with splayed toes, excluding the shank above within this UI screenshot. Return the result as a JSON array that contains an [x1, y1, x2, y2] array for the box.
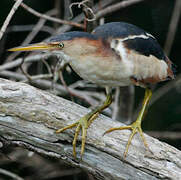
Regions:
[[104, 118, 149, 158]]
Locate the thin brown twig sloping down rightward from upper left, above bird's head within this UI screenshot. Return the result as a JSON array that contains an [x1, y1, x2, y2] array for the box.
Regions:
[[15, 0, 84, 28]]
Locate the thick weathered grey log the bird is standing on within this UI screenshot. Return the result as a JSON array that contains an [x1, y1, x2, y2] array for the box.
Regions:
[[0, 79, 181, 180]]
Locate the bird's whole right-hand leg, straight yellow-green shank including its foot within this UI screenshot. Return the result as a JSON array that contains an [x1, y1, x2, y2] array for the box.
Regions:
[[104, 88, 152, 157]]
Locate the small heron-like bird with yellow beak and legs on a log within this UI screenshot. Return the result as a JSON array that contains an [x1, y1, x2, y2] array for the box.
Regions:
[[9, 22, 175, 158]]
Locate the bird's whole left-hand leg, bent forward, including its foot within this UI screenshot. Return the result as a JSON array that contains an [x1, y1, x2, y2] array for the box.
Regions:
[[56, 89, 112, 158]]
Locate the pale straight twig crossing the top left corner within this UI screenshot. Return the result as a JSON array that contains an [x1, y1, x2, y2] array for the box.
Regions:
[[0, 0, 23, 40]]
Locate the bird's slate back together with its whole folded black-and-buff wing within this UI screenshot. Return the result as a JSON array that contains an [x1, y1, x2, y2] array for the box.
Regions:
[[92, 22, 174, 86]]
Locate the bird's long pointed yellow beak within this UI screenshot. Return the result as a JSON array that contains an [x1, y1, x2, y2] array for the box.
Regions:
[[8, 43, 55, 51]]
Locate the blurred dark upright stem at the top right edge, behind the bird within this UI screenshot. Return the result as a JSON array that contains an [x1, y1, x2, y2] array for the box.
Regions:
[[164, 0, 181, 55]]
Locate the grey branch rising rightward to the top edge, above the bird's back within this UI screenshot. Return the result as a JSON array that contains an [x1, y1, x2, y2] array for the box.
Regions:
[[96, 0, 144, 19]]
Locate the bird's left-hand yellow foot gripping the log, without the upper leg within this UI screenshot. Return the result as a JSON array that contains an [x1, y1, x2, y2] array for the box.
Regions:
[[56, 112, 99, 159]]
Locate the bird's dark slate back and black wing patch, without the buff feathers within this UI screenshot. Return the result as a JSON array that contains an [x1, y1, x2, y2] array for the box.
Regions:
[[93, 22, 166, 60]]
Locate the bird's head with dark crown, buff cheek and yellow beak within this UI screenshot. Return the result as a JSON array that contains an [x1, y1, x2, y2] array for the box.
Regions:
[[8, 31, 100, 58]]
